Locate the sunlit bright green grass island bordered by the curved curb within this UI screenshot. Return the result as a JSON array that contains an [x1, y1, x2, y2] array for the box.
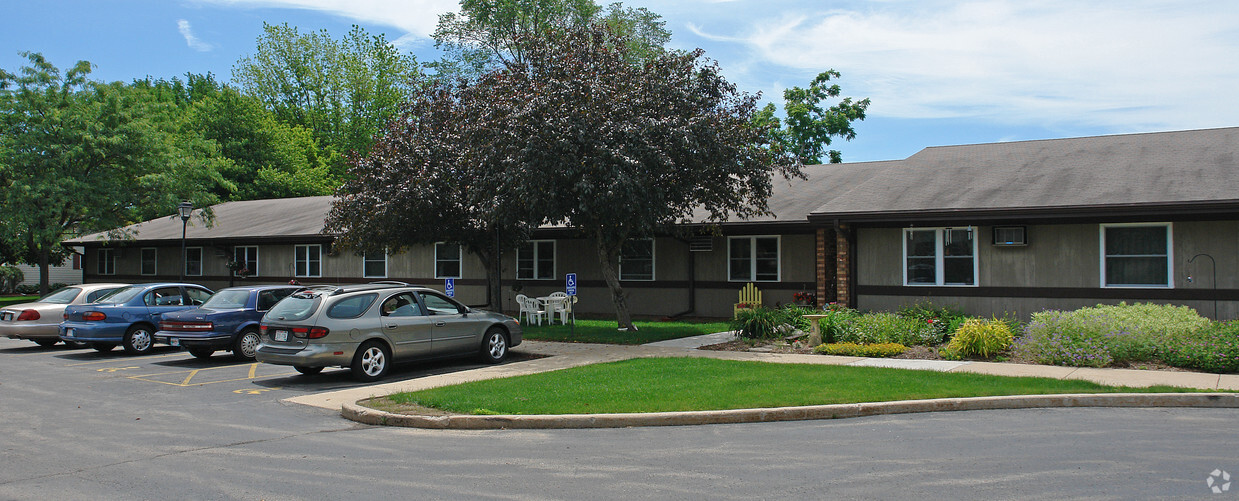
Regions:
[[369, 358, 1194, 414]]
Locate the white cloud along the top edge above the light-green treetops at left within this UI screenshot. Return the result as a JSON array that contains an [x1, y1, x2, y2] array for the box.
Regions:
[[190, 0, 460, 38]]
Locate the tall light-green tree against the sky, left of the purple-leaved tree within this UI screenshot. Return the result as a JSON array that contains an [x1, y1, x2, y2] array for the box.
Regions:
[[233, 25, 421, 162]]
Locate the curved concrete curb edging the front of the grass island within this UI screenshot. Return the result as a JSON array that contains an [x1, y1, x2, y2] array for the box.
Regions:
[[341, 393, 1239, 429]]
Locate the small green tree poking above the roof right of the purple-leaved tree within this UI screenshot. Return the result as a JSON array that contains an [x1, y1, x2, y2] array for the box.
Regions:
[[756, 69, 869, 164]]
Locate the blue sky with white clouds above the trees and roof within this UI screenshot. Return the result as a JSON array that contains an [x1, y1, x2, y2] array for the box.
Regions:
[[0, 0, 1239, 161]]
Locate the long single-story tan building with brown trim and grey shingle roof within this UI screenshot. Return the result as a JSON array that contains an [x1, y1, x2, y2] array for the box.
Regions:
[[64, 128, 1239, 319]]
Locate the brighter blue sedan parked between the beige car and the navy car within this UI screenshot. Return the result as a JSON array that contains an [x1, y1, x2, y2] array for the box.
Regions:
[[59, 284, 211, 355]]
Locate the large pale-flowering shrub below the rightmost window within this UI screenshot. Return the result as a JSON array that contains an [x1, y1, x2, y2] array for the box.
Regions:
[[1016, 303, 1209, 367]]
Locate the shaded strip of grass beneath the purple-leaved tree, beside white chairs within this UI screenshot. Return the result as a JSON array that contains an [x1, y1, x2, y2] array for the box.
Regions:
[[520, 319, 731, 345]]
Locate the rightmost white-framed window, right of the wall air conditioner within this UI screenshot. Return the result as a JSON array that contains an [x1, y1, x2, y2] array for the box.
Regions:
[[1101, 223, 1172, 286]]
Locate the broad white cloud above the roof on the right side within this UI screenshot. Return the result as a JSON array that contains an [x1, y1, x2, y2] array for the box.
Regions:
[[689, 0, 1239, 129]]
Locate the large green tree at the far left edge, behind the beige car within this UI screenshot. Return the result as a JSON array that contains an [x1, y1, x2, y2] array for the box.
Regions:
[[0, 52, 225, 293]]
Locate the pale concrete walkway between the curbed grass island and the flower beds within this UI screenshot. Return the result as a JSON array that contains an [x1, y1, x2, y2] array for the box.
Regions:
[[284, 332, 1239, 410]]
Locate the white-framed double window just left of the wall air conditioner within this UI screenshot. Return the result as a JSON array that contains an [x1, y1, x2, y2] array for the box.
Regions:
[[903, 228, 976, 285]]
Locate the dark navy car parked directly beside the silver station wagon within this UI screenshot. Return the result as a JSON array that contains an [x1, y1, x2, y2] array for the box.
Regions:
[[155, 285, 304, 360]]
